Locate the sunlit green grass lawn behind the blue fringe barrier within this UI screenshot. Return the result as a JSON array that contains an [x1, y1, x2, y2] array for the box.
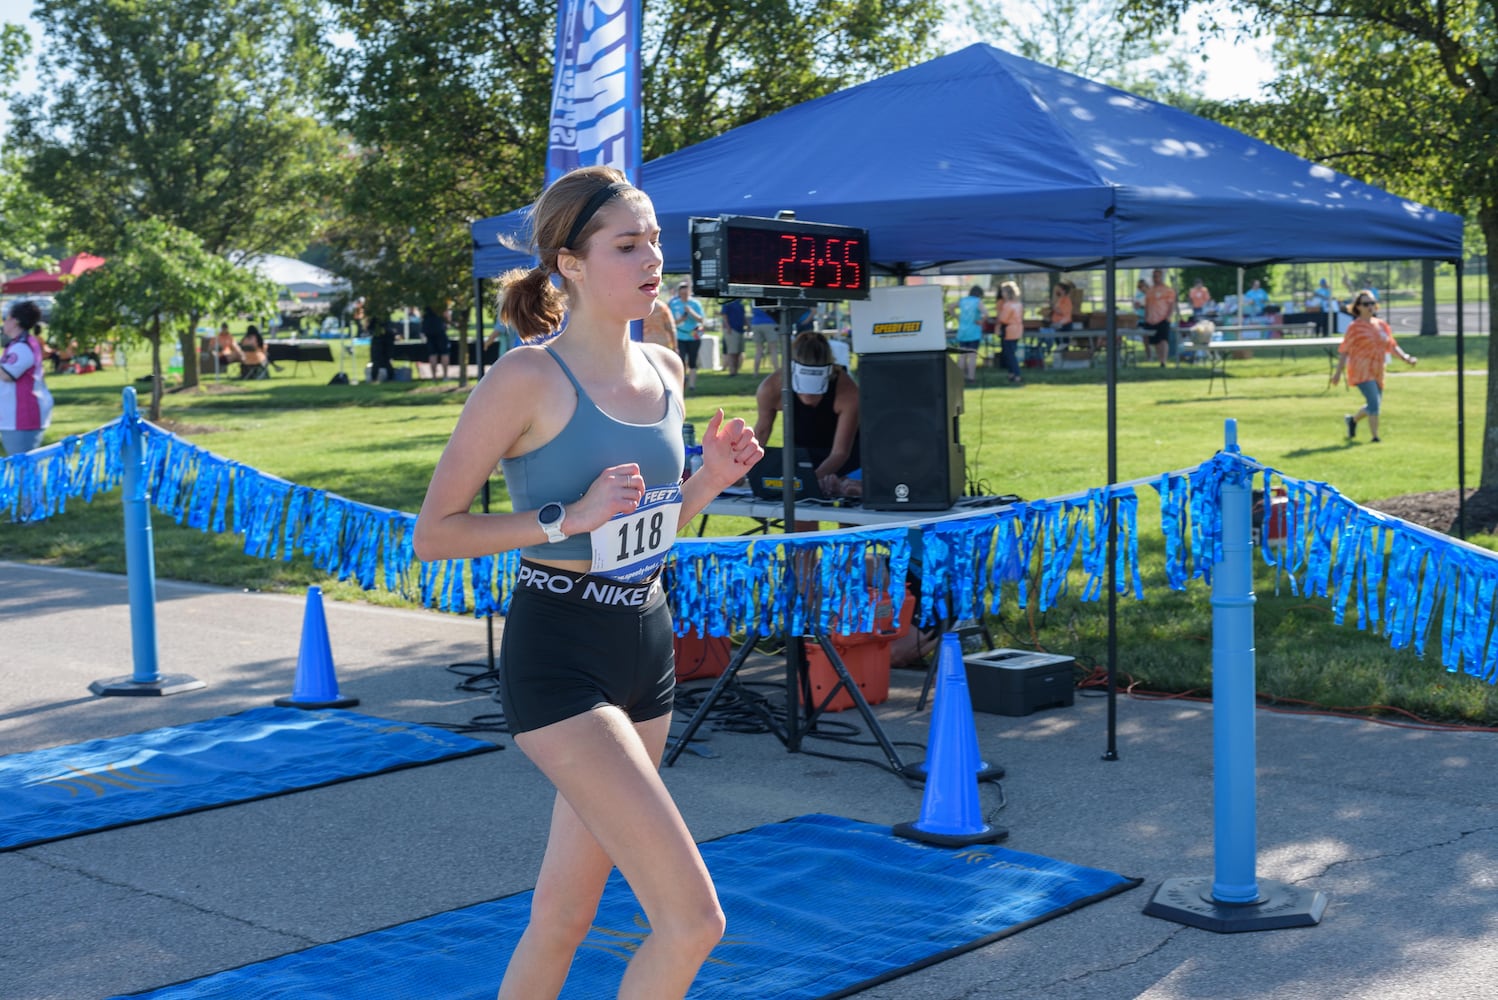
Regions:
[[11, 337, 1498, 725]]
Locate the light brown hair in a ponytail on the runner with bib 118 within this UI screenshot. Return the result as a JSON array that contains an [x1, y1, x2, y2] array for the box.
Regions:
[[499, 166, 650, 341]]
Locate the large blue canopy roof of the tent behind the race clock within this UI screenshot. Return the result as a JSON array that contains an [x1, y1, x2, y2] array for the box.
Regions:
[[473, 45, 1462, 277]]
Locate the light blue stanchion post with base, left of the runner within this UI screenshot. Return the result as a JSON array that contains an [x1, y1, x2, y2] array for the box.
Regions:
[[88, 386, 207, 696]]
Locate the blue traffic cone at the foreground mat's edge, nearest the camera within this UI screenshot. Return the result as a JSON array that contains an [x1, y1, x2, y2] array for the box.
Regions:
[[894, 632, 1010, 847]]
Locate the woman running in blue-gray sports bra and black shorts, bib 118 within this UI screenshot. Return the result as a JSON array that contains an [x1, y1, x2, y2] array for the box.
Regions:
[[413, 166, 764, 1000]]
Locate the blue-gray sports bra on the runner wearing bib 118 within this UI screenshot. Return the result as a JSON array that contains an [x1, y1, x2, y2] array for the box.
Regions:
[[499, 347, 686, 560]]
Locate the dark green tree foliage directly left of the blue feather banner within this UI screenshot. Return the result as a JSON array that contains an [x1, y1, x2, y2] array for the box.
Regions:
[[324, 0, 556, 359]]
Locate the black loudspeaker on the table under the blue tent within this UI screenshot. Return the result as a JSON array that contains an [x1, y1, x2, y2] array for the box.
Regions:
[[858, 350, 966, 510]]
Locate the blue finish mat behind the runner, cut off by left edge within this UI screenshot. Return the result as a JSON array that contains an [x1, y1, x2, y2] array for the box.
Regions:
[[0, 708, 499, 850]]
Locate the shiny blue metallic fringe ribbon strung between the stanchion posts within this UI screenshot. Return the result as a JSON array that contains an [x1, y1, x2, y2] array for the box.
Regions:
[[0, 418, 1498, 684]]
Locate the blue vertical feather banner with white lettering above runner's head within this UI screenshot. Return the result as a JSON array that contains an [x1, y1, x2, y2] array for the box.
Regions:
[[547, 0, 641, 186]]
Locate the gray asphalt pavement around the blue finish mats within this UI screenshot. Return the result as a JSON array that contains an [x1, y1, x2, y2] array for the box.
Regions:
[[0, 562, 1498, 1000]]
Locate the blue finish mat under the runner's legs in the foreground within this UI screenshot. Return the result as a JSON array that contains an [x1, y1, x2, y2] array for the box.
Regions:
[[115, 816, 1138, 1000]]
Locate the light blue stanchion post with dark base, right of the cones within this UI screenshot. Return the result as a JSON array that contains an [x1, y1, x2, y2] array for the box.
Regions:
[[1144, 419, 1326, 934]]
